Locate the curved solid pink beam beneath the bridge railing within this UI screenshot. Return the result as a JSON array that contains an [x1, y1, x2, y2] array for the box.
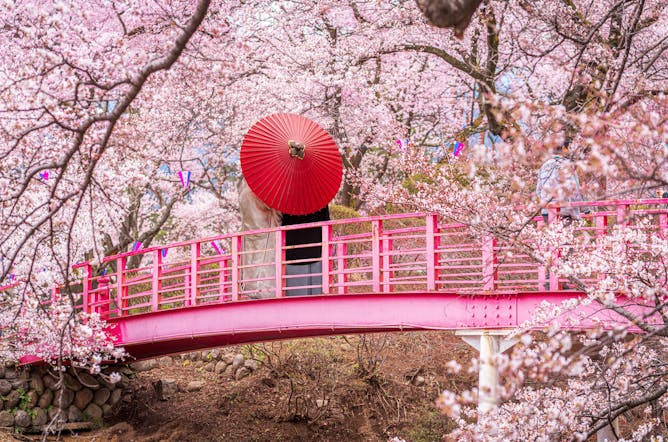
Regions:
[[110, 292, 652, 359]]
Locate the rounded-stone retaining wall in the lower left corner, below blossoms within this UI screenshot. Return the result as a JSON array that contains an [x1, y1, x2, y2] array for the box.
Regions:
[[0, 366, 132, 432]]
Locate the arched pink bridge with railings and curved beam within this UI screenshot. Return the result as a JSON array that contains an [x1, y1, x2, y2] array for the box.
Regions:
[[44, 199, 668, 359]]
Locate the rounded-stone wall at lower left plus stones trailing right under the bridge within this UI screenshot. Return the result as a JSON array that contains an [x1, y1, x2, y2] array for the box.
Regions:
[[0, 348, 259, 432]]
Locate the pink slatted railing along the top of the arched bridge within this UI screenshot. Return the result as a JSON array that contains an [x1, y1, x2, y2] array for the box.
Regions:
[[45, 199, 668, 319]]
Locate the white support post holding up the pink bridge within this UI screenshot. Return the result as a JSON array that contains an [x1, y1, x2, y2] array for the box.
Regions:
[[456, 330, 517, 414]]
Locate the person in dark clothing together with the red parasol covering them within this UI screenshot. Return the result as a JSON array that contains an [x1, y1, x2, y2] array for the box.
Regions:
[[240, 114, 343, 296]]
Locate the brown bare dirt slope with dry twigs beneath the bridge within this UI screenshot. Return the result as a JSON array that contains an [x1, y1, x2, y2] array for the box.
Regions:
[[6, 332, 475, 442]]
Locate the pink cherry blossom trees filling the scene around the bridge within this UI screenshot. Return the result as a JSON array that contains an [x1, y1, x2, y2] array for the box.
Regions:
[[0, 0, 668, 439]]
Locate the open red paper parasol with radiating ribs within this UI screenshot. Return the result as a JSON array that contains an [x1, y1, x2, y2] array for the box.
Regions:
[[241, 114, 343, 215]]
